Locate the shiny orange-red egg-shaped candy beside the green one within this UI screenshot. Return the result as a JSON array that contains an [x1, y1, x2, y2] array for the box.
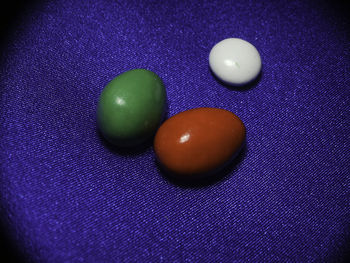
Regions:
[[154, 108, 245, 175]]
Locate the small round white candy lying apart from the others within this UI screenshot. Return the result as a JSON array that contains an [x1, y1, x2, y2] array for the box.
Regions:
[[209, 38, 261, 86]]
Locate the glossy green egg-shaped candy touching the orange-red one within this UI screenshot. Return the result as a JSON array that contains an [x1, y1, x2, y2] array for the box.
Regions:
[[97, 69, 166, 146]]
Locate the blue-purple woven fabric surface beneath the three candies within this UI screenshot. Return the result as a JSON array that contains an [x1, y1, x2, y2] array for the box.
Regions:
[[0, 0, 350, 262]]
